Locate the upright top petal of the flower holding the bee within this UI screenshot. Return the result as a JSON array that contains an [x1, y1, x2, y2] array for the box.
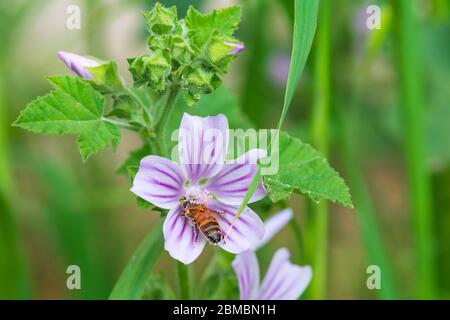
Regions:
[[178, 113, 228, 183]]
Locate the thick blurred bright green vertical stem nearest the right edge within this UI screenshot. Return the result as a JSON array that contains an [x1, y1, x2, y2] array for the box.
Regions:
[[395, 0, 437, 299]]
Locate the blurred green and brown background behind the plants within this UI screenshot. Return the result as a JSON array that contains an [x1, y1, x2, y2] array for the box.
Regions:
[[0, 0, 450, 299]]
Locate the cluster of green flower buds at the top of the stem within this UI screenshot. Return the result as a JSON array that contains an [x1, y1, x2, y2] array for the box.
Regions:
[[128, 3, 244, 104]]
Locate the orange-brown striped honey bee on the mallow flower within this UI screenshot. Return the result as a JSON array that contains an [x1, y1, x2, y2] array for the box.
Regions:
[[180, 197, 224, 245]]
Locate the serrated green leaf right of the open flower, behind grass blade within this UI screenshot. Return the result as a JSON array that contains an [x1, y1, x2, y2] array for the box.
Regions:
[[264, 132, 353, 207]]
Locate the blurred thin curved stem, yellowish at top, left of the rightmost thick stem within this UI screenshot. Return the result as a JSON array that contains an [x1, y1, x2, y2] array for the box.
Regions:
[[335, 5, 398, 299]]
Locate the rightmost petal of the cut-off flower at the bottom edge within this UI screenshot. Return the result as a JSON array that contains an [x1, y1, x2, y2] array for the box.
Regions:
[[258, 248, 312, 300]]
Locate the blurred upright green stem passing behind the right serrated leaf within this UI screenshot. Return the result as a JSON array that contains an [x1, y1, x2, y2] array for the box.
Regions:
[[308, 1, 331, 299]]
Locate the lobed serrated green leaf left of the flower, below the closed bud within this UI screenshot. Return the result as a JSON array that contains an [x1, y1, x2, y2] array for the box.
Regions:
[[14, 76, 120, 160]]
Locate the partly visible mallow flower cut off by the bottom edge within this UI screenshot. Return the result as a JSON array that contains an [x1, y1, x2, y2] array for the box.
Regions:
[[232, 209, 312, 300]]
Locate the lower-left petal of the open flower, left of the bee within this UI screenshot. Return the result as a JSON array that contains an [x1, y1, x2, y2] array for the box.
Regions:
[[163, 205, 206, 264]]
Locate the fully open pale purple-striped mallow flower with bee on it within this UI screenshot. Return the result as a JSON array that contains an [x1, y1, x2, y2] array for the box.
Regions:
[[131, 113, 266, 264]]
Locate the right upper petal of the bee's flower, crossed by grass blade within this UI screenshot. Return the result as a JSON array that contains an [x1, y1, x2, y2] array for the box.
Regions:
[[206, 149, 267, 205]]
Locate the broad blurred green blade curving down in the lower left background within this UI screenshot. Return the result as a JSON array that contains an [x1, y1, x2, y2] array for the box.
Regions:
[[27, 159, 111, 299]]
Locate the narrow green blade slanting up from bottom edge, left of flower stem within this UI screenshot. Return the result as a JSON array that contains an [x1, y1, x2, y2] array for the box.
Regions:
[[109, 221, 163, 300]]
